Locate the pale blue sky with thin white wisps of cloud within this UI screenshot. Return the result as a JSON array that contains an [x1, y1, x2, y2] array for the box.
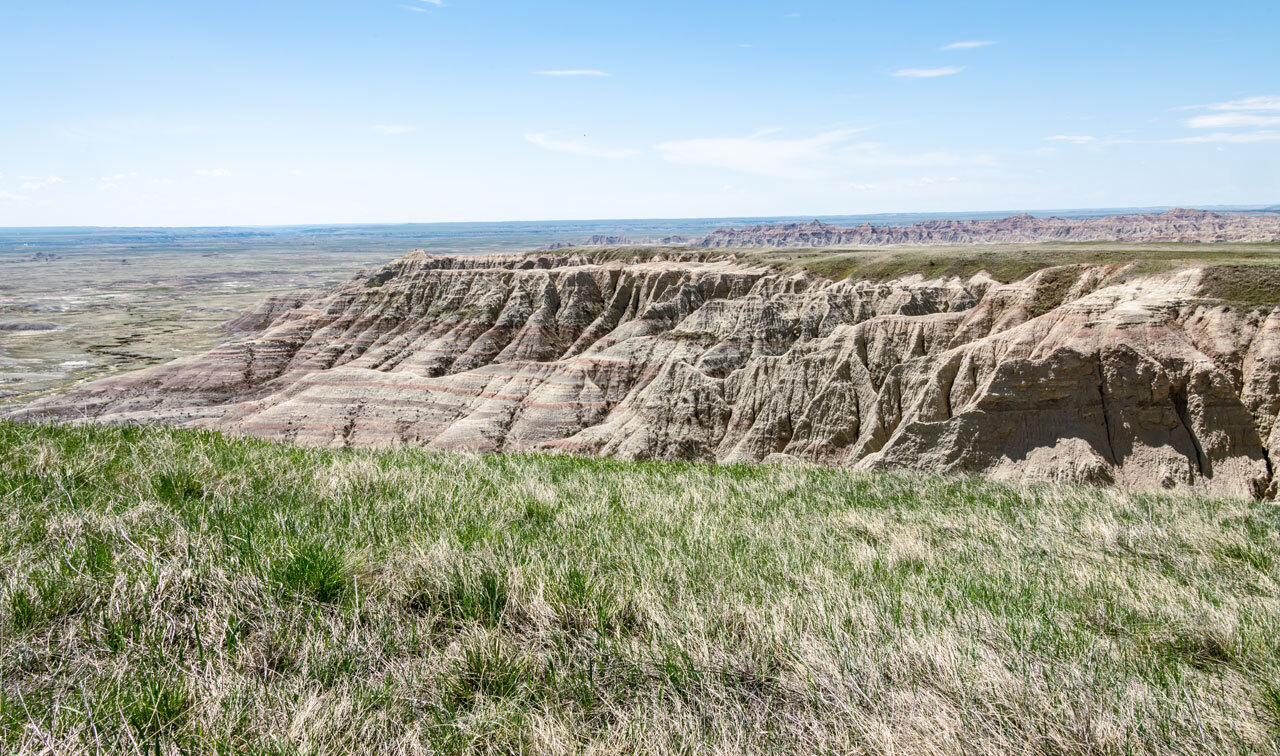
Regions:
[[0, 0, 1280, 225]]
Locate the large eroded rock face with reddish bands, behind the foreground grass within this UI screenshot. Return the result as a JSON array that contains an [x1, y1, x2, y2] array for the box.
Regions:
[[18, 253, 1280, 496]]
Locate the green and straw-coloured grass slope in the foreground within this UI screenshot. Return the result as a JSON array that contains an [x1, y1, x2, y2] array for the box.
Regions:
[[0, 423, 1280, 755]]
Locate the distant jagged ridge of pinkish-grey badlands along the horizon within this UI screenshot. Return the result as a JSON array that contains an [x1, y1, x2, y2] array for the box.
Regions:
[[692, 210, 1280, 248]]
